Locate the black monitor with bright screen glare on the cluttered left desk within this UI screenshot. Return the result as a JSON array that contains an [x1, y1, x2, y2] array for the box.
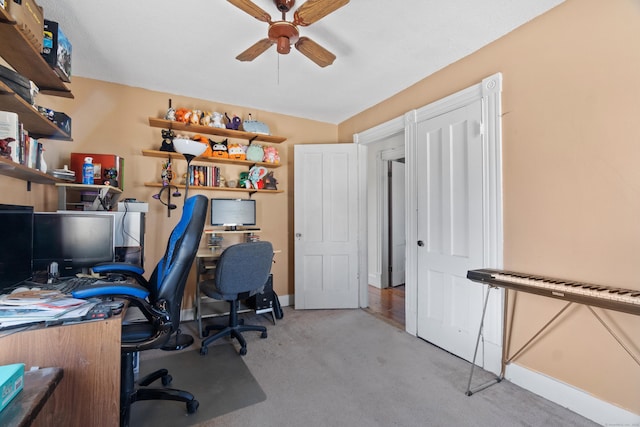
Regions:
[[33, 212, 115, 277]]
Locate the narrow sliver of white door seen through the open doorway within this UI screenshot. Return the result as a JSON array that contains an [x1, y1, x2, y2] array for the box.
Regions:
[[389, 160, 407, 286]]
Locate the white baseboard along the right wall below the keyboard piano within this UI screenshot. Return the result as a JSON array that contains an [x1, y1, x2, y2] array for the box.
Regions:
[[504, 364, 640, 426]]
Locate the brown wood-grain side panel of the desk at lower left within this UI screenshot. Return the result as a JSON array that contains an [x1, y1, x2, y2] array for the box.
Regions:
[[0, 316, 122, 427]]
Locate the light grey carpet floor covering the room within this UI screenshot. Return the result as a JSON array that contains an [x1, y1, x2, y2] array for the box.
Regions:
[[132, 307, 598, 427]]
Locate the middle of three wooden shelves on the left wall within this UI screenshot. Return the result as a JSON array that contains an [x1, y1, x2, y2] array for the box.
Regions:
[[0, 81, 71, 141]]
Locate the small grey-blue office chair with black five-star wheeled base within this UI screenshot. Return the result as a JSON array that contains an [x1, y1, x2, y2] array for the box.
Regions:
[[200, 242, 273, 356]]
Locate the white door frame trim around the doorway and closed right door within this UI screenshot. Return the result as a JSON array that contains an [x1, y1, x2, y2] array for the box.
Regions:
[[353, 73, 504, 368]]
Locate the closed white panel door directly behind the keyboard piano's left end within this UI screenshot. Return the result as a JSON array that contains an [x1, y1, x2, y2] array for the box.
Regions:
[[412, 100, 483, 360]]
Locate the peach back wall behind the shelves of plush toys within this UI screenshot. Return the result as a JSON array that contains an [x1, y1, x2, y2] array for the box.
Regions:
[[0, 77, 337, 308]]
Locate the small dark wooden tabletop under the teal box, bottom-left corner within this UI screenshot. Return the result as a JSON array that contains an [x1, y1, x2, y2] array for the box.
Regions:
[[0, 368, 63, 427]]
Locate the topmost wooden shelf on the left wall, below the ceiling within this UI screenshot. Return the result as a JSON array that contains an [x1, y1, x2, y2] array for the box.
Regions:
[[0, 8, 73, 98]]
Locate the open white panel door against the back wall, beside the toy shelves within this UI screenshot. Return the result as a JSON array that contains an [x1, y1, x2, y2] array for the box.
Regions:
[[294, 144, 360, 309]]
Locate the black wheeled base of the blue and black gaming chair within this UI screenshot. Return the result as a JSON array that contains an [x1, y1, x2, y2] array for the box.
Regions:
[[120, 353, 200, 427]]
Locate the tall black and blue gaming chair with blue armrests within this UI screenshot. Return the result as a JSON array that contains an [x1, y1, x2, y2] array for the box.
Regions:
[[73, 195, 208, 426]]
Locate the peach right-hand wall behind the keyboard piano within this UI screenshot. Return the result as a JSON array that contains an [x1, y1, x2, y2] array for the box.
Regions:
[[339, 0, 640, 414]]
